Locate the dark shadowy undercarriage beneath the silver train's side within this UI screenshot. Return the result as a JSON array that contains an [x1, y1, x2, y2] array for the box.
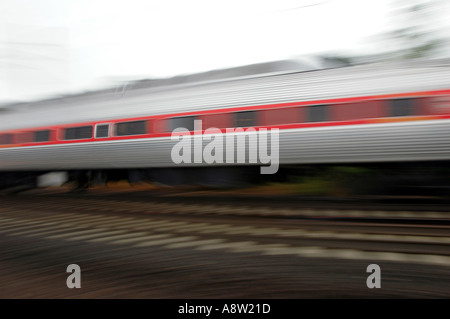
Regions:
[[0, 161, 450, 197]]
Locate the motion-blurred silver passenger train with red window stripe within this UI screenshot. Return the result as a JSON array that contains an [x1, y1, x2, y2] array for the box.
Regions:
[[0, 59, 450, 194]]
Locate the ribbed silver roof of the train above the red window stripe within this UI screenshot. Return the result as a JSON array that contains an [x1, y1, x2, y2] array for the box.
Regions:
[[0, 59, 450, 130]]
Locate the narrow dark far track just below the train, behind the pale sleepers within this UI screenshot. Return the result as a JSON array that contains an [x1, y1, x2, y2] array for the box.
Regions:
[[7, 189, 450, 223]]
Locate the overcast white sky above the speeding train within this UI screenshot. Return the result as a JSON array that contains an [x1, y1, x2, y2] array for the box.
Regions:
[[0, 0, 446, 104]]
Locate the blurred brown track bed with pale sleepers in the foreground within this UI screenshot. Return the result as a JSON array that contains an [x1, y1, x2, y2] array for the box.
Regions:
[[0, 190, 450, 298]]
